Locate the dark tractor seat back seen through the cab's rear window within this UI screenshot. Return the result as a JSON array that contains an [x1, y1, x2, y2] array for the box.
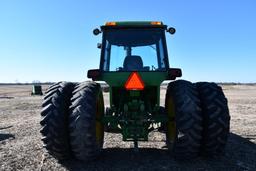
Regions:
[[123, 55, 143, 71]]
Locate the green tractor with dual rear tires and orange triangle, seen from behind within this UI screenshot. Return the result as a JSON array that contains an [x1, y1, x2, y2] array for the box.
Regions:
[[40, 22, 230, 161]]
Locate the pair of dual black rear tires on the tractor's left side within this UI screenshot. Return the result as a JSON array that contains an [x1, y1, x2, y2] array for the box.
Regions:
[[40, 82, 104, 161]]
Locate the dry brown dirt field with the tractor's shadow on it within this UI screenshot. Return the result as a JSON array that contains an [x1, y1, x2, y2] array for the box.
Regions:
[[0, 85, 256, 171]]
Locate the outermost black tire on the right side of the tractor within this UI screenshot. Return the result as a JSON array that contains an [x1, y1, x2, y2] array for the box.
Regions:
[[196, 82, 230, 156]]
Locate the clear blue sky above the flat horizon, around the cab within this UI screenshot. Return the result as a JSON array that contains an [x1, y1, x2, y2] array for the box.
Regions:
[[0, 0, 256, 83]]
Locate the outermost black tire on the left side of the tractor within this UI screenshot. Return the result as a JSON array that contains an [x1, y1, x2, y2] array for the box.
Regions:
[[40, 82, 74, 160]]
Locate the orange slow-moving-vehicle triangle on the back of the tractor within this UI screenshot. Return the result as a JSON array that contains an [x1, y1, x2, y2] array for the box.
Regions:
[[125, 72, 144, 90]]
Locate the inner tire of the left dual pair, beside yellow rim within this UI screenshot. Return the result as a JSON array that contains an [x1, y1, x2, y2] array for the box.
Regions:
[[69, 82, 104, 161]]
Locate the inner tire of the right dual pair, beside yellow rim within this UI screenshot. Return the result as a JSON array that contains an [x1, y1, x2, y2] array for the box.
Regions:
[[165, 80, 202, 159]]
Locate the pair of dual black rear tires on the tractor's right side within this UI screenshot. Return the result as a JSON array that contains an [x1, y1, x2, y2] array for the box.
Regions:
[[165, 80, 230, 159]]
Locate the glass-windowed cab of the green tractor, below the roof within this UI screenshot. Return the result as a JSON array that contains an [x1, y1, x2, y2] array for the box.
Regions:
[[100, 21, 169, 72]]
